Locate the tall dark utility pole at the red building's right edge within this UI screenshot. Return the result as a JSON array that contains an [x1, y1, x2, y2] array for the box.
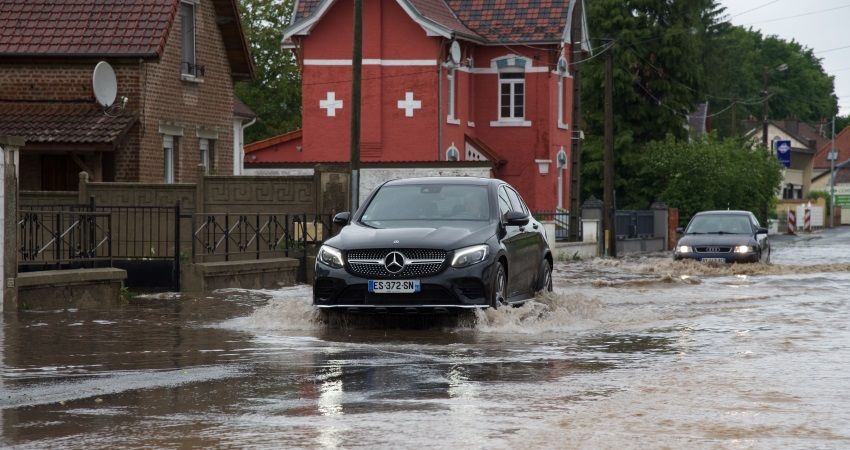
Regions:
[[568, 0, 584, 242]]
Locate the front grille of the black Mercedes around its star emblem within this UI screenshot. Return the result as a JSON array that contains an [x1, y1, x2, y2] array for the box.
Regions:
[[346, 248, 448, 278]]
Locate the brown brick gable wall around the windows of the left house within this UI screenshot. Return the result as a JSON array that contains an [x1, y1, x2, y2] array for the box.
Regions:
[[139, 0, 233, 182]]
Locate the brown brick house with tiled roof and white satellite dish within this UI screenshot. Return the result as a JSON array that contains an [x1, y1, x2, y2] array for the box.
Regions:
[[0, 0, 254, 190]]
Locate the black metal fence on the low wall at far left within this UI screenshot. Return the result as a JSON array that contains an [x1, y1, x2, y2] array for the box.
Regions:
[[17, 210, 113, 269]]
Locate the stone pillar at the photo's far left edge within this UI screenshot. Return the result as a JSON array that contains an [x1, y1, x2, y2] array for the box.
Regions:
[[0, 136, 24, 311]]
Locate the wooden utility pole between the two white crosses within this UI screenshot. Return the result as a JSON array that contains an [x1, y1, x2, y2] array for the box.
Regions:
[[350, 0, 363, 213]]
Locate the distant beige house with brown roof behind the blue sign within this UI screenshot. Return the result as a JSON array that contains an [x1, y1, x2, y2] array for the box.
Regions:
[[746, 119, 827, 200]]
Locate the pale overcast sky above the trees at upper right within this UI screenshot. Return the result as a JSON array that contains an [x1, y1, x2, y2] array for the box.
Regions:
[[719, 0, 850, 115]]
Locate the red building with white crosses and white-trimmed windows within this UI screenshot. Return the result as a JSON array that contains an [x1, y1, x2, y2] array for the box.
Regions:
[[245, 0, 587, 210]]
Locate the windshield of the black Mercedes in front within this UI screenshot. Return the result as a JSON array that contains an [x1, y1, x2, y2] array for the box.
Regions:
[[360, 184, 490, 228]]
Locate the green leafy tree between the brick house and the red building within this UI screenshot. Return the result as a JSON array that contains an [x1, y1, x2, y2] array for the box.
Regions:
[[235, 0, 301, 142]]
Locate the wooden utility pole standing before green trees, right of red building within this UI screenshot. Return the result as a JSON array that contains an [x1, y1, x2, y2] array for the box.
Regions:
[[603, 45, 617, 258]]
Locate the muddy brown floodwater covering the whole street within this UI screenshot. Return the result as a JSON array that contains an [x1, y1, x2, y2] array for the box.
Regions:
[[0, 229, 850, 449]]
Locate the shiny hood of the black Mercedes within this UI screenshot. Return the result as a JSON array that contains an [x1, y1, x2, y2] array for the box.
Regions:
[[327, 223, 495, 250]]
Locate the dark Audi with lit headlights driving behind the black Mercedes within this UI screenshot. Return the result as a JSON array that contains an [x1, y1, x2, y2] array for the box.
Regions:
[[673, 211, 770, 263]]
